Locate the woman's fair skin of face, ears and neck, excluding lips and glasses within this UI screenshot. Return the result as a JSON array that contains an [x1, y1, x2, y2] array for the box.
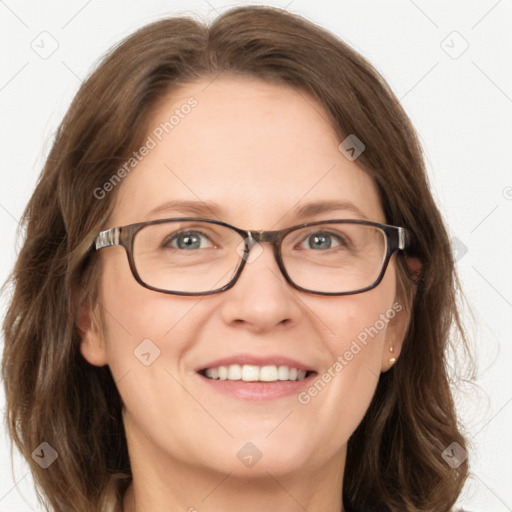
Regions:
[[80, 76, 407, 512]]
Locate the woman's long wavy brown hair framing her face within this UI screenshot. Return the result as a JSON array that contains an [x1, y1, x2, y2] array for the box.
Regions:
[[2, 7, 468, 512]]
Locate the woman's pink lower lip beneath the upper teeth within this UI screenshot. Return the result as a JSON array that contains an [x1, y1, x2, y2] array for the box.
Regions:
[[199, 373, 316, 400]]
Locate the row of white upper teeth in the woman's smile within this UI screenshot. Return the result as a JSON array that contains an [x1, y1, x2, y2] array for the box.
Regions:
[[205, 364, 307, 382]]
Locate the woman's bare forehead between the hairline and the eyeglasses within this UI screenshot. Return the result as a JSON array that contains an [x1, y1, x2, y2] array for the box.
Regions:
[[112, 76, 384, 229]]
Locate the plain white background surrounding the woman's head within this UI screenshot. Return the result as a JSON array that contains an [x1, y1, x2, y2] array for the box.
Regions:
[[0, 0, 512, 512]]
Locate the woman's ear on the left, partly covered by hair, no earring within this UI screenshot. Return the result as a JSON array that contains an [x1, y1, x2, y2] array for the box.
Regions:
[[76, 300, 108, 366]]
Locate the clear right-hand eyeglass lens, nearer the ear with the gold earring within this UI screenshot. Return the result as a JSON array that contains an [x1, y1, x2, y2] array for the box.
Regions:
[[282, 223, 387, 293]]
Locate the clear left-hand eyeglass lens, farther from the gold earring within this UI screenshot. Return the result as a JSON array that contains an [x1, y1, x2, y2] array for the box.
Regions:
[[133, 221, 243, 293]]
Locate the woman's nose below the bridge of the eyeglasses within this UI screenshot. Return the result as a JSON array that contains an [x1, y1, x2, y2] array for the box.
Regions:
[[221, 243, 301, 333]]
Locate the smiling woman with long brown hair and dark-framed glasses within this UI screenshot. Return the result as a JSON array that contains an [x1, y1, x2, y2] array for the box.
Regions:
[[3, 7, 468, 512]]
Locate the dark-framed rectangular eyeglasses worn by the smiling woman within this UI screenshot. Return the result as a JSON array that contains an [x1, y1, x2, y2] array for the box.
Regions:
[[93, 218, 408, 295]]
